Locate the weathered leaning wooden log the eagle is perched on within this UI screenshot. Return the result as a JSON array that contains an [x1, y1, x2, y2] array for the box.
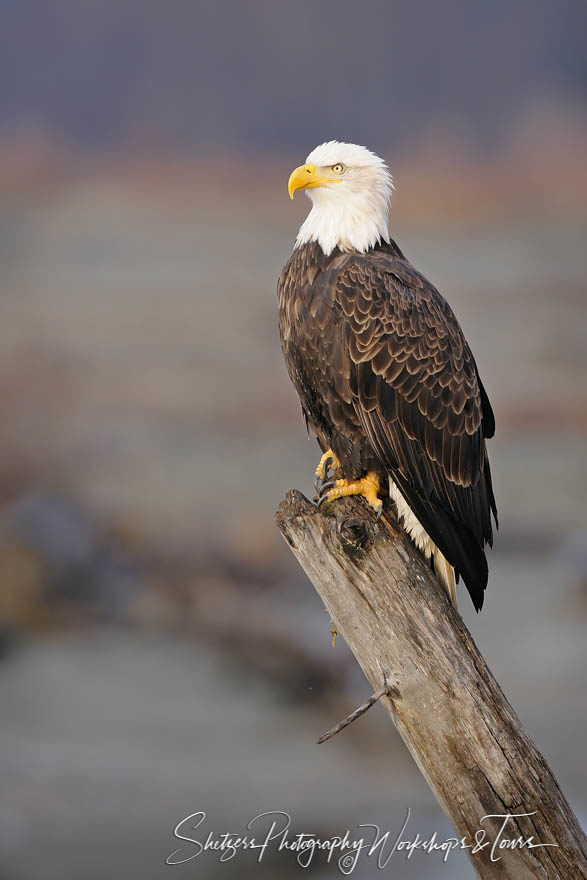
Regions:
[[277, 491, 587, 880]]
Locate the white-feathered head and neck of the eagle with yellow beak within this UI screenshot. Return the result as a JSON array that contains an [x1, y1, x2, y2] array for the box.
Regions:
[[287, 141, 393, 255]]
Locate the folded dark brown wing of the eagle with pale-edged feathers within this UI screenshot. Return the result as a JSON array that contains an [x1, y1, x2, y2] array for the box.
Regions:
[[331, 252, 497, 608]]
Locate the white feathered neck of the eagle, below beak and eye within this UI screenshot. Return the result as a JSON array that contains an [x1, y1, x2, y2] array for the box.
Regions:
[[295, 189, 389, 256]]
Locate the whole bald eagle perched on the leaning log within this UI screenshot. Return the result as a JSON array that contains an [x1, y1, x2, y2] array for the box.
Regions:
[[278, 141, 497, 611]]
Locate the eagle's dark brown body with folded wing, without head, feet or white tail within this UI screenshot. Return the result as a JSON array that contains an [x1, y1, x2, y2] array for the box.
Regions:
[[278, 242, 496, 609]]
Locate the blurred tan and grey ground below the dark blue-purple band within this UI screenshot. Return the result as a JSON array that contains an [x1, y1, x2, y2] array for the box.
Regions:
[[0, 144, 587, 880]]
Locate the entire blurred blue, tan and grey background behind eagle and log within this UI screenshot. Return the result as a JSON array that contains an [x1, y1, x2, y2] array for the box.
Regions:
[[0, 0, 587, 880]]
